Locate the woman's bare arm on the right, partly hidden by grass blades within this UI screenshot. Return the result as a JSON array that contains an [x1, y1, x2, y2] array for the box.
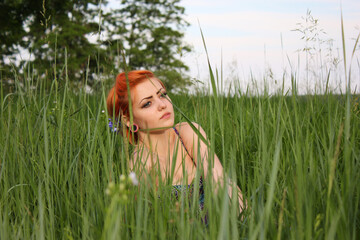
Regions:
[[179, 123, 245, 211]]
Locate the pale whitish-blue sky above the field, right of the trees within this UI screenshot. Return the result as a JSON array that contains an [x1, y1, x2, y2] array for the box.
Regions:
[[181, 0, 360, 93]]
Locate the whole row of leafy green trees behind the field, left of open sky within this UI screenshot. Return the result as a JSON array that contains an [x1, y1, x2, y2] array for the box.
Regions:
[[0, 0, 191, 89]]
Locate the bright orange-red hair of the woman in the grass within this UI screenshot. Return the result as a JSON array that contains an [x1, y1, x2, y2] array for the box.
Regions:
[[106, 70, 165, 143]]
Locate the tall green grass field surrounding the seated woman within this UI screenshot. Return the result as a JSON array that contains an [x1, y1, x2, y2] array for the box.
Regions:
[[0, 68, 360, 239]]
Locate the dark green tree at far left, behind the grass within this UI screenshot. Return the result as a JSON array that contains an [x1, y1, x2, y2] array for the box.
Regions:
[[0, 0, 106, 84]]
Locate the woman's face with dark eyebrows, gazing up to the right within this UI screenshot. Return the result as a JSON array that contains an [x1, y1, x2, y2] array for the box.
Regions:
[[131, 78, 174, 129]]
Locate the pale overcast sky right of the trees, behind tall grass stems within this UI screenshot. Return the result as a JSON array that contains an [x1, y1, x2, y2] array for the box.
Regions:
[[182, 0, 360, 91]]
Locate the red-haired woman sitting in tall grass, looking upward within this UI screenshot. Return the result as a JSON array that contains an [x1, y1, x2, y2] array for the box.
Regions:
[[107, 70, 244, 213]]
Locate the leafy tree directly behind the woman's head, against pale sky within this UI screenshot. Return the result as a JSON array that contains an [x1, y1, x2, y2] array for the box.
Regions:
[[105, 0, 191, 92]]
